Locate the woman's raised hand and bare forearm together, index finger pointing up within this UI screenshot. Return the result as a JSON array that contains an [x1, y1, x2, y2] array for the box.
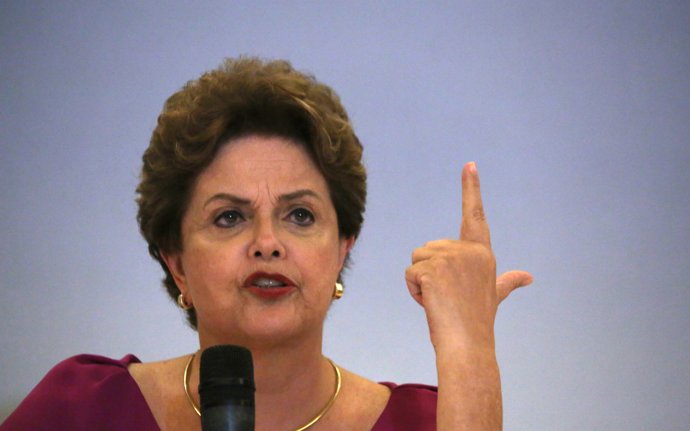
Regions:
[[405, 163, 532, 431]]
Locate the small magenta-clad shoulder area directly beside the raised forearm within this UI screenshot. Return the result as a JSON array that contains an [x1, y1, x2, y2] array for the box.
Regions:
[[373, 382, 438, 431]]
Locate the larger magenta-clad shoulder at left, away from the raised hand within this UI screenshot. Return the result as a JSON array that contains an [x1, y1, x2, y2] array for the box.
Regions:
[[2, 354, 155, 430]]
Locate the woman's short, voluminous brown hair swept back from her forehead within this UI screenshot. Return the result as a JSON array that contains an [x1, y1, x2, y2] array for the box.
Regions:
[[136, 58, 366, 329]]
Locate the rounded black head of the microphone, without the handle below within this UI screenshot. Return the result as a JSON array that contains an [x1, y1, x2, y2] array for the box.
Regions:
[[199, 345, 254, 412]]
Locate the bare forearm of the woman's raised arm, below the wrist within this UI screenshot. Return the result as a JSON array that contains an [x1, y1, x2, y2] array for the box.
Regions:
[[436, 347, 503, 431]]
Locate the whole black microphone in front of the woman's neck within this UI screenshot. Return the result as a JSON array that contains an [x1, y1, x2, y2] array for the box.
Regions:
[[199, 345, 255, 431]]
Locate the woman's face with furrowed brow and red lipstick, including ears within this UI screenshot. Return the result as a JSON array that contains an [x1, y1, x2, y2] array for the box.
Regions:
[[165, 135, 354, 347]]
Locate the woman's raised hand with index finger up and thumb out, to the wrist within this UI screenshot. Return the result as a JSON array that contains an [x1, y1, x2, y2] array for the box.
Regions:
[[405, 162, 532, 349]]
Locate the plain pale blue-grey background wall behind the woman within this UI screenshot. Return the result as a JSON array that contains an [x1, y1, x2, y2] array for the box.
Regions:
[[0, 1, 690, 430]]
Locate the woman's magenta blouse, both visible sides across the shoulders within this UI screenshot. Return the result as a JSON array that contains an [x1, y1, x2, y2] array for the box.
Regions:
[[0, 355, 437, 431]]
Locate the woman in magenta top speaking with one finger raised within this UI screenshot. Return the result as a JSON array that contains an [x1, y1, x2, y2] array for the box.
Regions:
[[2, 59, 531, 431]]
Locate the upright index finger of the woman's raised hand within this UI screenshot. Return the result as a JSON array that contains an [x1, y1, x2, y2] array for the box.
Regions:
[[460, 162, 491, 247]]
